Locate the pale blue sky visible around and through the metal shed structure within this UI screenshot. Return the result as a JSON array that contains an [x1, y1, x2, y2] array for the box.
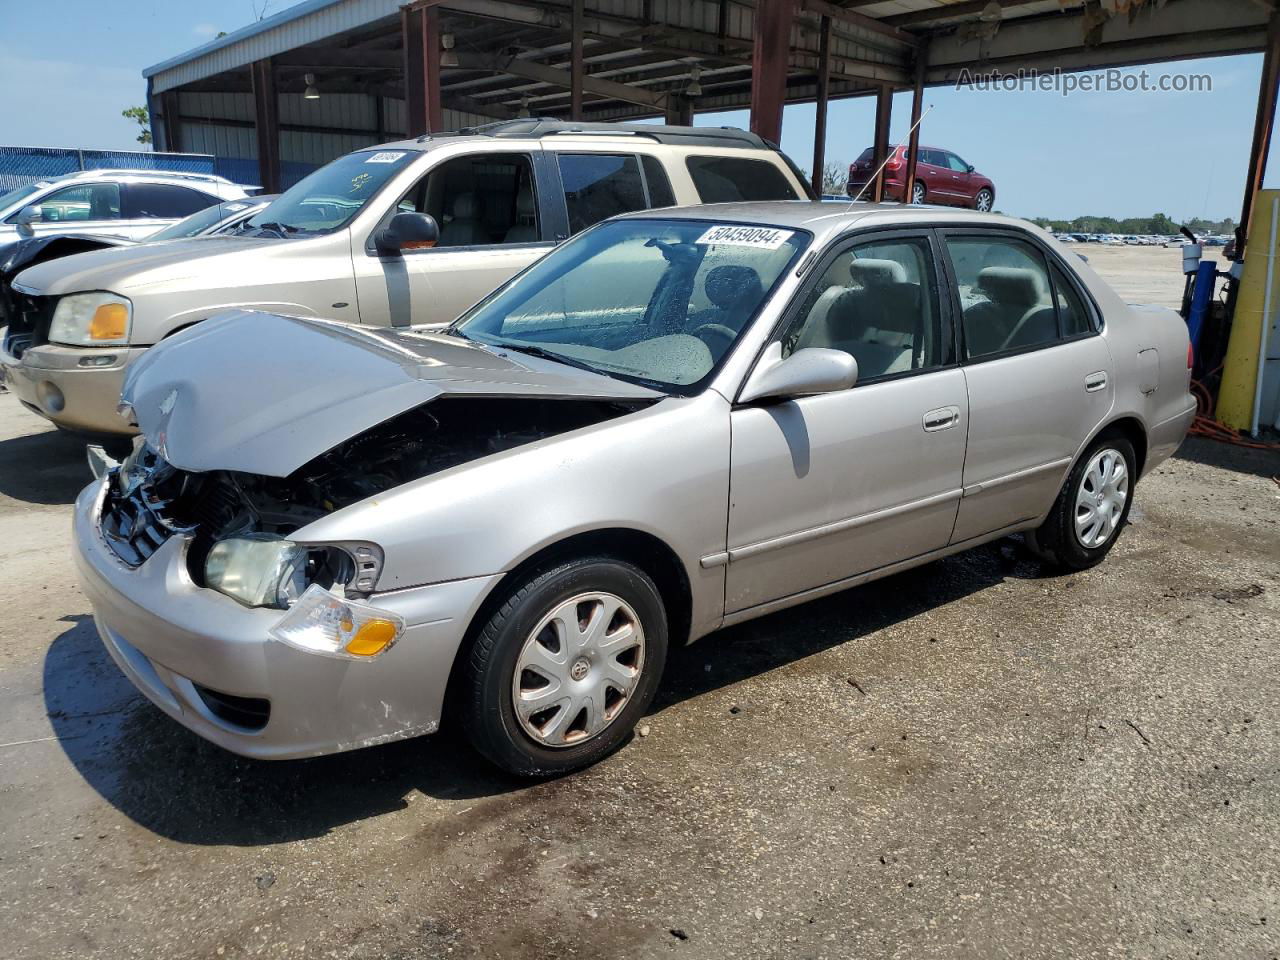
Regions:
[[0, 0, 1280, 219]]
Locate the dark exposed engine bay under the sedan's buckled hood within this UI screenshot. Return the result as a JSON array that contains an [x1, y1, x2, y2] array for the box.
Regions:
[[102, 397, 652, 585]]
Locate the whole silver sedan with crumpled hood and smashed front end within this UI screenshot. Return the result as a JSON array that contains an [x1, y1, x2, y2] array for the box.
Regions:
[[76, 204, 1194, 776]]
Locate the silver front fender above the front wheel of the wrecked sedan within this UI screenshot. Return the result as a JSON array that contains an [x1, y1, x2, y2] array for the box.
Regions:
[[292, 390, 730, 639]]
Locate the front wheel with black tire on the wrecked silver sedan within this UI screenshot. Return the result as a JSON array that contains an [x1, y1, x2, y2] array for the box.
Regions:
[[458, 557, 667, 777]]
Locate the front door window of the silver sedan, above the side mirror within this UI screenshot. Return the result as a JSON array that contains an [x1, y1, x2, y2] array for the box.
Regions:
[[782, 237, 943, 383]]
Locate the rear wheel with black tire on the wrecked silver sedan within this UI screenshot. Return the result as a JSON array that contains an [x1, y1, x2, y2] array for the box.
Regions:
[[1027, 433, 1138, 571]]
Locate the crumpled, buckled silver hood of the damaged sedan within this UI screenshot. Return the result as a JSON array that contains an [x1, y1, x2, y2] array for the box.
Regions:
[[123, 310, 663, 476]]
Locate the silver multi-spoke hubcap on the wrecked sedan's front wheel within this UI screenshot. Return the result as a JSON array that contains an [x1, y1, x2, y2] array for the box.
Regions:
[[512, 593, 644, 746]]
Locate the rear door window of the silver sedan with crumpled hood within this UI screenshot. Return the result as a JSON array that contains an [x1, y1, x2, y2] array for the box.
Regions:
[[946, 236, 1059, 360]]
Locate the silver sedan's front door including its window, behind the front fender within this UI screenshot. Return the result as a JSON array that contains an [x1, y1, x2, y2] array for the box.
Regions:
[[724, 230, 968, 614]]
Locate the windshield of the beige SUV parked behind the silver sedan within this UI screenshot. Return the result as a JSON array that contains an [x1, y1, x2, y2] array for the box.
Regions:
[[244, 150, 421, 237]]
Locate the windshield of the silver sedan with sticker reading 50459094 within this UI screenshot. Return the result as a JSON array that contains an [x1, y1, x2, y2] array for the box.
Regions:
[[453, 220, 809, 393]]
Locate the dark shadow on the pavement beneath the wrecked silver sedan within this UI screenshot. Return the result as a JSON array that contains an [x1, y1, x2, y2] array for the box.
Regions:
[[44, 540, 1037, 845]]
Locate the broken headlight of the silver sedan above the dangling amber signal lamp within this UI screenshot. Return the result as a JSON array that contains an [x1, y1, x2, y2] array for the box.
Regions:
[[205, 534, 356, 611]]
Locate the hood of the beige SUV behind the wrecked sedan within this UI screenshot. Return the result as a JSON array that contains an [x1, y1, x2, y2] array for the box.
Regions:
[[15, 236, 272, 296]]
